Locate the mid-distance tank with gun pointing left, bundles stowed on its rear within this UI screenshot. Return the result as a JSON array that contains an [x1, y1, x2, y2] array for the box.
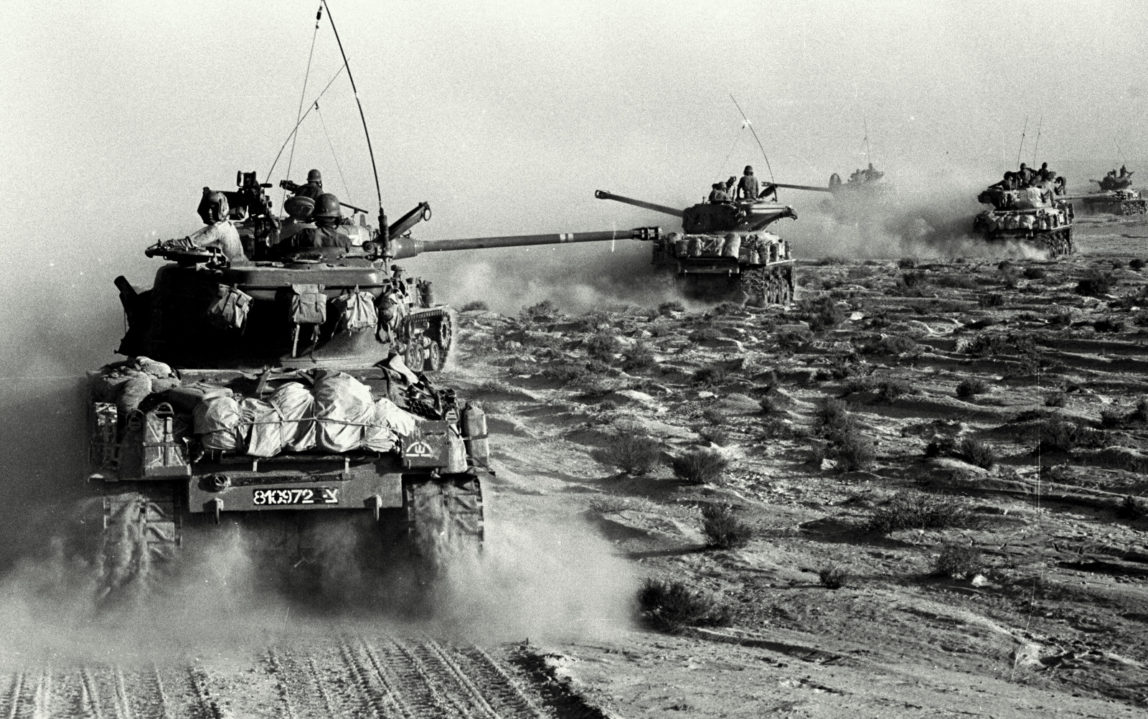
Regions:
[[595, 190, 797, 307]]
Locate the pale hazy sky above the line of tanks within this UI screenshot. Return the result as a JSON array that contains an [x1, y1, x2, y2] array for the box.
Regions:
[[0, 0, 1148, 369]]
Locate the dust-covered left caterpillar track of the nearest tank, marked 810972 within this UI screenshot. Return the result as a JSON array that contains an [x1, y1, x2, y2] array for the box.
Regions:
[[95, 487, 180, 606]]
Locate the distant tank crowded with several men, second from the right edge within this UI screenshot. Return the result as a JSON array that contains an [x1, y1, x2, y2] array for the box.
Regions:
[[972, 173, 1075, 257]]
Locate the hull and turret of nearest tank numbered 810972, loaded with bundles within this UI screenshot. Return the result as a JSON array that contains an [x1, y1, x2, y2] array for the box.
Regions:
[[87, 205, 492, 601]]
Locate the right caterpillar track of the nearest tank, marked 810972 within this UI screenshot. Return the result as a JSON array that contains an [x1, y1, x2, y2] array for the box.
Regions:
[[403, 474, 483, 569]]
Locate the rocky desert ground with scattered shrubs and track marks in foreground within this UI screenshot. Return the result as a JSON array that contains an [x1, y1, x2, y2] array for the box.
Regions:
[[0, 217, 1148, 717]]
